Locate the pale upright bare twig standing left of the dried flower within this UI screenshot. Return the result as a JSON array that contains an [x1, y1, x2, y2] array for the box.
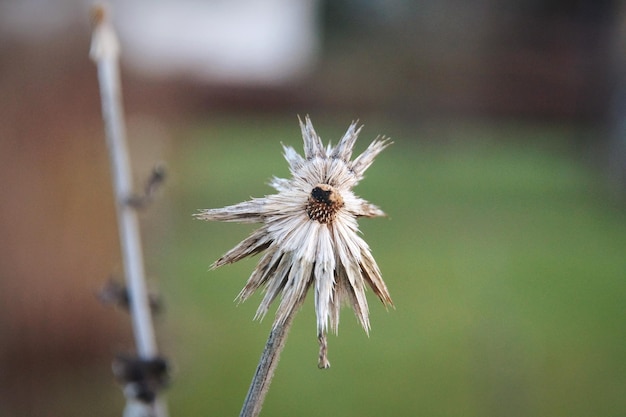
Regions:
[[90, 5, 167, 417]]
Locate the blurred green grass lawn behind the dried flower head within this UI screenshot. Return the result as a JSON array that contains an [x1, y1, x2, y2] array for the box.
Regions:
[[155, 116, 626, 417]]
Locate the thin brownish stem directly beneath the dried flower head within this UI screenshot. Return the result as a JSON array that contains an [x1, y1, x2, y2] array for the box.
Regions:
[[239, 308, 297, 417]]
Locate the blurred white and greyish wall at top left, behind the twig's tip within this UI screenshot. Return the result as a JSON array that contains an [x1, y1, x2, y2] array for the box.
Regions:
[[0, 0, 320, 85]]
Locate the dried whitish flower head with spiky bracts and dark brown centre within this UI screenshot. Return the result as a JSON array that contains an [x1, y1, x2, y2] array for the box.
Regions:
[[196, 117, 393, 367]]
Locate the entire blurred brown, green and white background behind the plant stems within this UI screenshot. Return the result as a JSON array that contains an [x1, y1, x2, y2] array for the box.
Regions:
[[0, 0, 626, 417]]
